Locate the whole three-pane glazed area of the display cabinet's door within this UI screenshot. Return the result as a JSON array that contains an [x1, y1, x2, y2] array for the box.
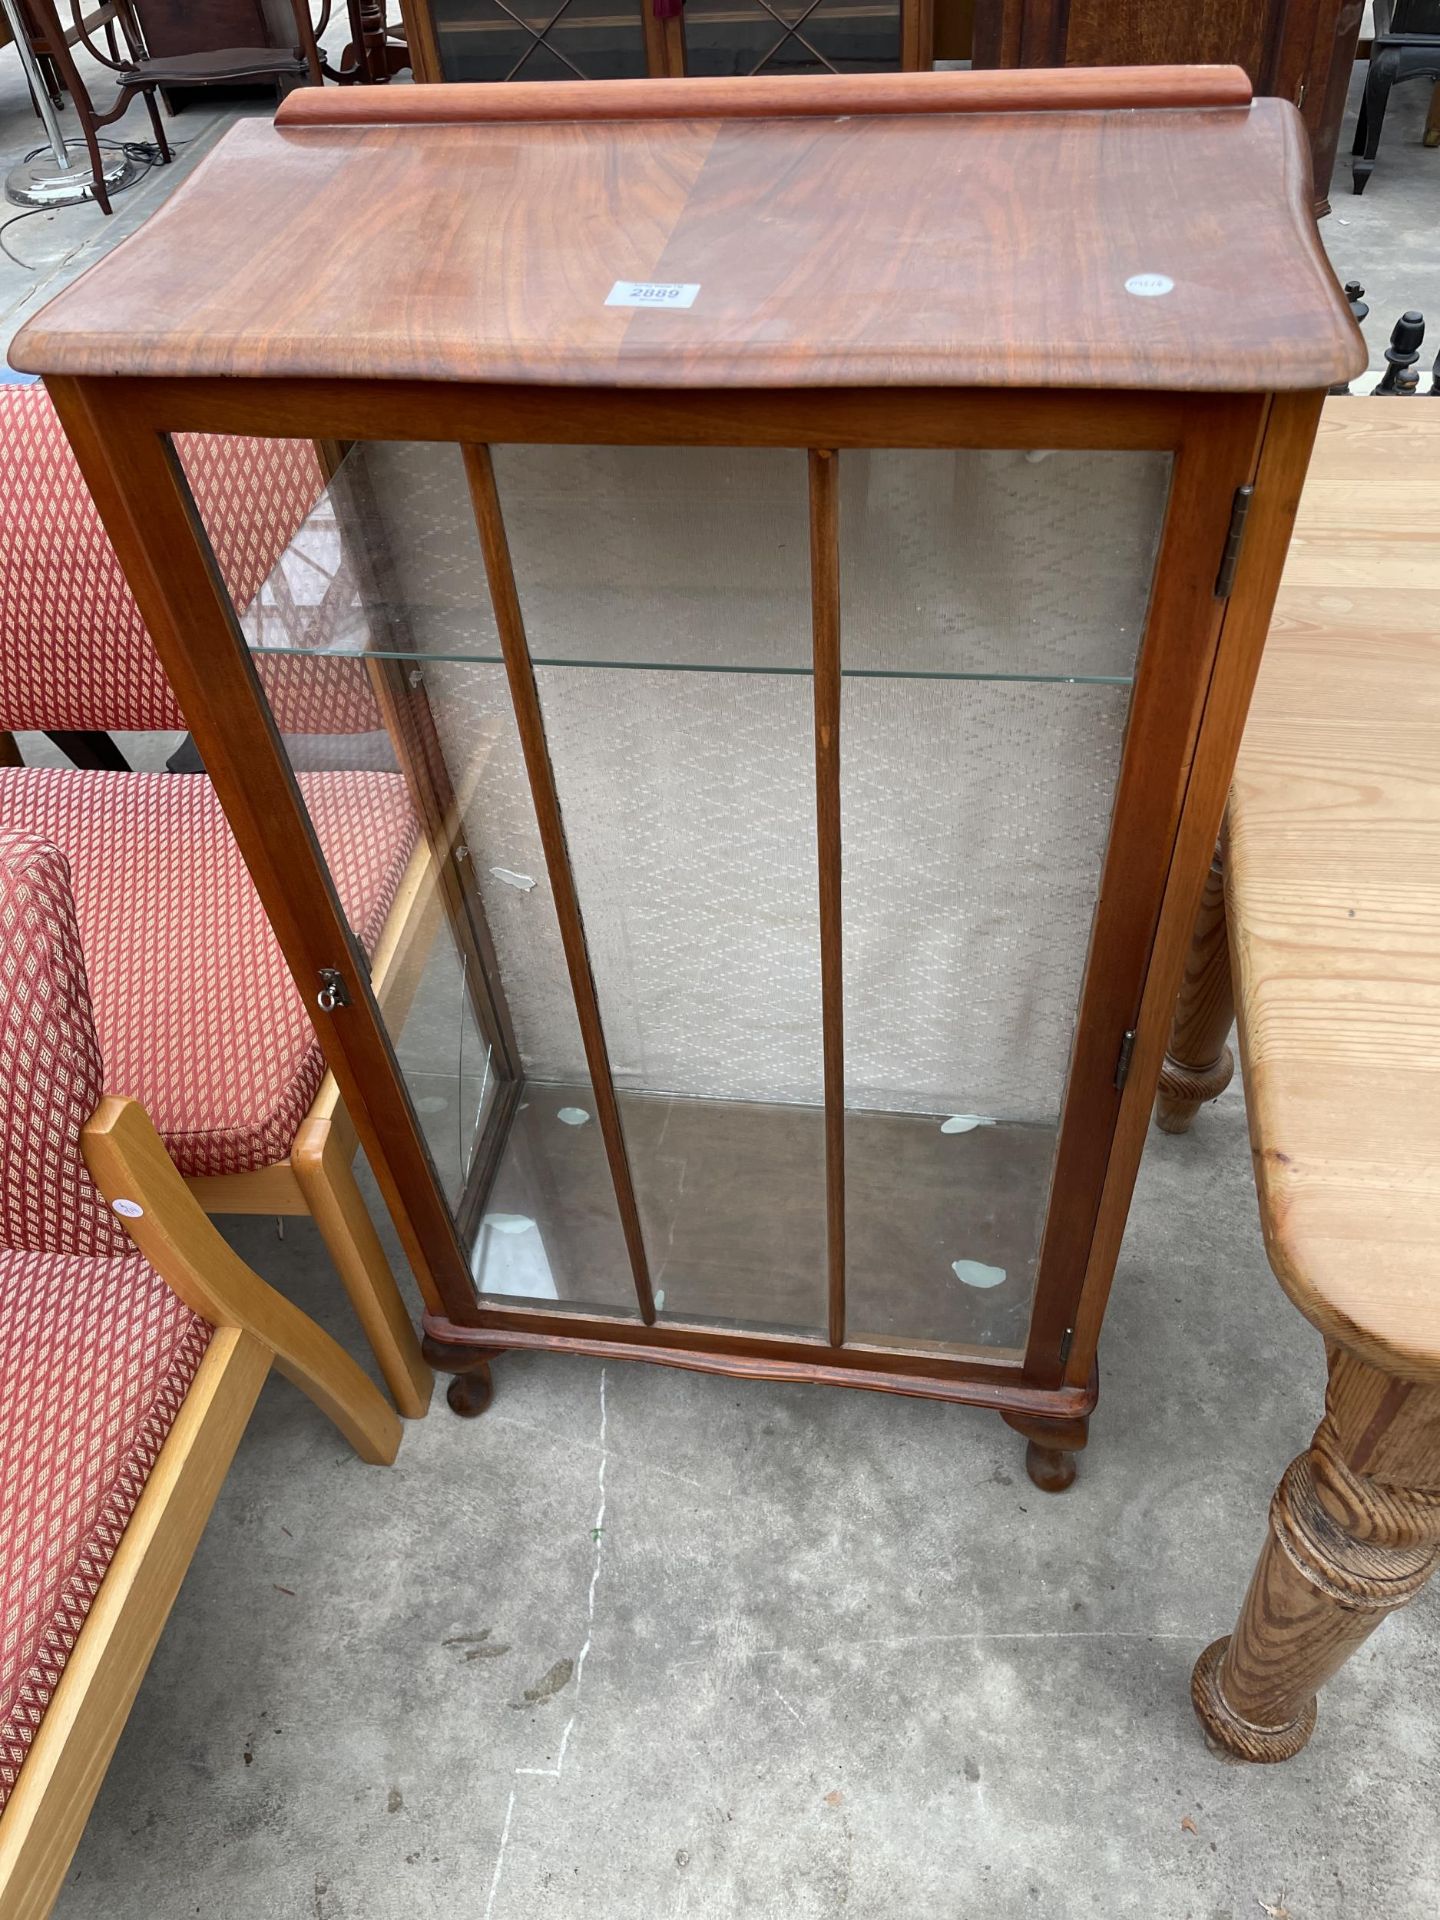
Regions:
[[180, 442, 1169, 1356]]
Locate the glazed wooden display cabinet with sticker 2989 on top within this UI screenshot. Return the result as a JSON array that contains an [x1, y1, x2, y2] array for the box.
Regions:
[[15, 69, 1363, 1486]]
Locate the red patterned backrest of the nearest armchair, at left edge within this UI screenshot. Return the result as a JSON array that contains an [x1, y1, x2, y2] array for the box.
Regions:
[[0, 828, 131, 1254]]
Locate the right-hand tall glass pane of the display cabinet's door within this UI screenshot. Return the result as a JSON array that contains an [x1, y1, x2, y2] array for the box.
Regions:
[[841, 449, 1169, 1348]]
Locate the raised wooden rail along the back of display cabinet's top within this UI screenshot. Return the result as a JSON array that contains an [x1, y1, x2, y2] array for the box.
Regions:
[[275, 67, 1252, 131]]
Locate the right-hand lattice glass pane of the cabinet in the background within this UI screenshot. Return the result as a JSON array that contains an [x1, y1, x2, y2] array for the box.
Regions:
[[684, 0, 900, 75]]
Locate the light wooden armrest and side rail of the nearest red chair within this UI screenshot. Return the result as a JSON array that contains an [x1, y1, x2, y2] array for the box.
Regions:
[[0, 1096, 401, 1920]]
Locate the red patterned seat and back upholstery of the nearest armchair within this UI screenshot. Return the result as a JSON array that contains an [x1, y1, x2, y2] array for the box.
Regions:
[[0, 828, 209, 1807]]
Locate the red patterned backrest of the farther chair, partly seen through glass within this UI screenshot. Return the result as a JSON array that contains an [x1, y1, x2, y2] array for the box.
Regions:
[[0, 386, 380, 733]]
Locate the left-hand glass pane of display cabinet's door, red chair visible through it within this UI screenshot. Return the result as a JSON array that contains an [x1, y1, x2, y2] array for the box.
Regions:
[[174, 442, 636, 1315]]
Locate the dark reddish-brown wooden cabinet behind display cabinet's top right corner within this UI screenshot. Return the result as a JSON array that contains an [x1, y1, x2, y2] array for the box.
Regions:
[[975, 0, 1365, 213]]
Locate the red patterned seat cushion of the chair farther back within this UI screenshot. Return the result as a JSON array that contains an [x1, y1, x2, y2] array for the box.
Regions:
[[0, 768, 417, 1173]]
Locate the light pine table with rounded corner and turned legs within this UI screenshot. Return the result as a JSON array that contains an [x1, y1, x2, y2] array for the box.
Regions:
[[1158, 397, 1440, 1761]]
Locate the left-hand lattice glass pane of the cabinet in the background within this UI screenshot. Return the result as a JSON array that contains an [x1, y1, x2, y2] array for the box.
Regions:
[[430, 0, 647, 81]]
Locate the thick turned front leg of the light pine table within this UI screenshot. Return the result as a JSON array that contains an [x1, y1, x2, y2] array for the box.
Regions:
[[1190, 1348, 1440, 1761]]
